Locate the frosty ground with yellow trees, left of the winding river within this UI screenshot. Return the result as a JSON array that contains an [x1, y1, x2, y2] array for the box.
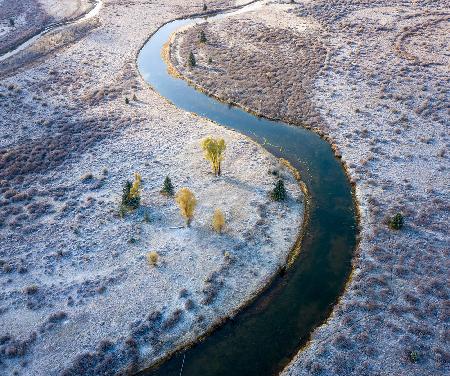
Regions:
[[0, 0, 303, 376]]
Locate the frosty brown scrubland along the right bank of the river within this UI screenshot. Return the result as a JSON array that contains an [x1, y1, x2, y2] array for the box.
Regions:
[[171, 0, 450, 376]]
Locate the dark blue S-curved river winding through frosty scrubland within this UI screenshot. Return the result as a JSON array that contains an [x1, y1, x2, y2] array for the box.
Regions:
[[138, 4, 358, 376]]
